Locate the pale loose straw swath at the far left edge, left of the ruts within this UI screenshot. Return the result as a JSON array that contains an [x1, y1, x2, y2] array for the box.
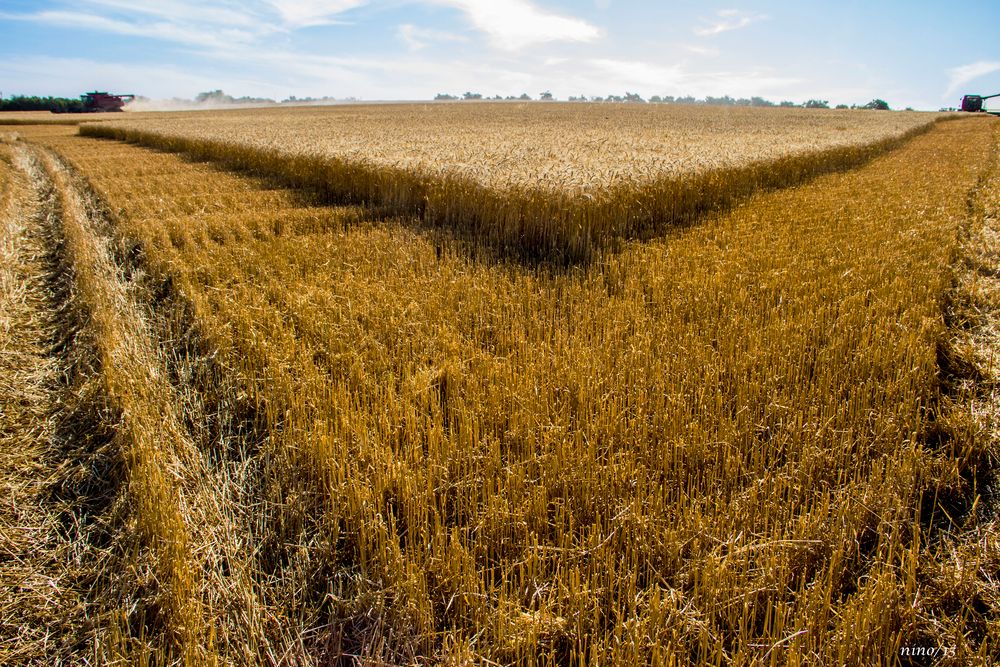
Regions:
[[0, 143, 91, 664]]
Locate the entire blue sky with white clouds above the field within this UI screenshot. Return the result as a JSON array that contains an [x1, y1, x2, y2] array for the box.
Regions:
[[0, 0, 1000, 109]]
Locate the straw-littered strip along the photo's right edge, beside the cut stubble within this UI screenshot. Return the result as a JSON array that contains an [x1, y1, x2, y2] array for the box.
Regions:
[[919, 118, 1000, 659]]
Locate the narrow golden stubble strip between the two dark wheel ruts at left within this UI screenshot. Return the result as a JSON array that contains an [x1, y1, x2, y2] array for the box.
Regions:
[[34, 141, 223, 664]]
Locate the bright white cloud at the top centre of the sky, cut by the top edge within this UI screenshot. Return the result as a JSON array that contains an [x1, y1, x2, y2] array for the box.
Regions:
[[432, 0, 601, 51]]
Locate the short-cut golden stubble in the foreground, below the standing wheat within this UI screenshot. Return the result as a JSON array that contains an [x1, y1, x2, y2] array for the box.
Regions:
[[3, 113, 996, 665]]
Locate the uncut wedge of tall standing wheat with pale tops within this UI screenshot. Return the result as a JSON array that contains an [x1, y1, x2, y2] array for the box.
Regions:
[[81, 104, 937, 262]]
